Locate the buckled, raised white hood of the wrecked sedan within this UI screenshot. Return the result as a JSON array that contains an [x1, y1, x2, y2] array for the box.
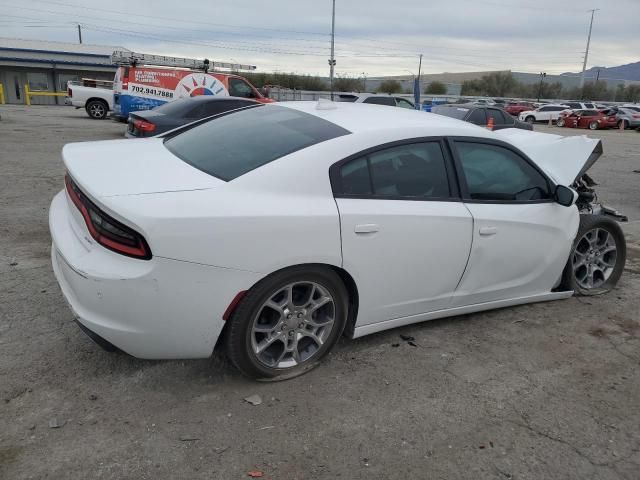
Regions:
[[496, 128, 602, 186]]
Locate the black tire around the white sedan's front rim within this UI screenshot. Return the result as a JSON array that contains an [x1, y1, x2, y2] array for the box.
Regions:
[[561, 215, 627, 296]]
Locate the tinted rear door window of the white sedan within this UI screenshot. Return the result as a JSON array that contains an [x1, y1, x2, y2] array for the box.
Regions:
[[339, 142, 451, 199]]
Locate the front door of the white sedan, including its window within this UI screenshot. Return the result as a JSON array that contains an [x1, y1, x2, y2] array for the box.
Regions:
[[452, 139, 579, 306]]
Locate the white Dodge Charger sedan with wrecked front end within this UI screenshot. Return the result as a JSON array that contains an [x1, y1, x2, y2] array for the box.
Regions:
[[50, 102, 626, 379]]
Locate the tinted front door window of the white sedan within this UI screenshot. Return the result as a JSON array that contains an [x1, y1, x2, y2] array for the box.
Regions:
[[456, 142, 551, 201]]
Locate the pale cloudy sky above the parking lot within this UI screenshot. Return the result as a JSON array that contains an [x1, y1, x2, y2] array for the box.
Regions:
[[0, 0, 640, 77]]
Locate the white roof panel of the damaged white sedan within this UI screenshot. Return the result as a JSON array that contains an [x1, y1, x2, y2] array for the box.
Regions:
[[276, 101, 488, 137]]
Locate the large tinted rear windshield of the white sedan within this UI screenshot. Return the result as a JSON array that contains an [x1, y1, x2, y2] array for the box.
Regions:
[[164, 105, 351, 181]]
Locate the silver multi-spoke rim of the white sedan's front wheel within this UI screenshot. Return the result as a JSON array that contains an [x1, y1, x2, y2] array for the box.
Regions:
[[571, 228, 618, 290]]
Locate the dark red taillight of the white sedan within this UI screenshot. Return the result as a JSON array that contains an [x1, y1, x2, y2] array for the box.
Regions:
[[64, 175, 151, 260]]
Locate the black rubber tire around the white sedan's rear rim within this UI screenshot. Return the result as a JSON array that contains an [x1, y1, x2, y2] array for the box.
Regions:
[[225, 265, 348, 381]]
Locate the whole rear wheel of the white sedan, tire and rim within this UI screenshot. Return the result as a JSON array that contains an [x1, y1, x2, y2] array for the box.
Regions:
[[226, 266, 348, 380]]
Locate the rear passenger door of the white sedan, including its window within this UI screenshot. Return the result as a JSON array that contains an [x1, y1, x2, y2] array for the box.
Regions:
[[331, 139, 473, 325]]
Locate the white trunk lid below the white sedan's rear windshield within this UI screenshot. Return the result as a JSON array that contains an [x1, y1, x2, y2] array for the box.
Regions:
[[62, 138, 222, 198]]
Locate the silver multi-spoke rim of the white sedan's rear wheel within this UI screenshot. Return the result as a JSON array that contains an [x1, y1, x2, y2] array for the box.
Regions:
[[250, 281, 336, 369]]
